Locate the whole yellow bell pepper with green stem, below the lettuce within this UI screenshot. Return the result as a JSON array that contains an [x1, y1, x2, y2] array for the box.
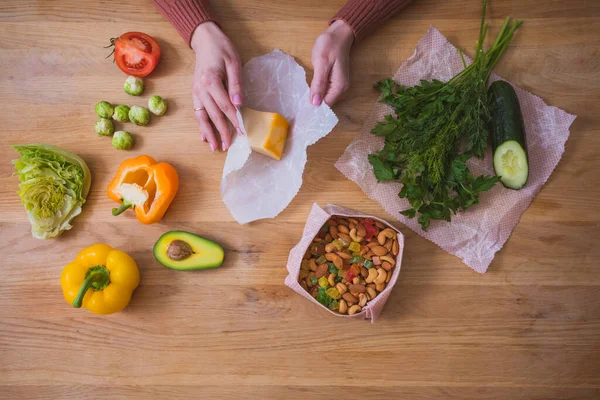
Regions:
[[60, 243, 140, 314]]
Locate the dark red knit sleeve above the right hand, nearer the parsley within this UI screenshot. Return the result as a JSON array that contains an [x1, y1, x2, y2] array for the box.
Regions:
[[329, 0, 412, 40]]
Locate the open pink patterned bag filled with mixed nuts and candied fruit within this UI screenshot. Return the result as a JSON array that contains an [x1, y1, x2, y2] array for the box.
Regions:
[[285, 203, 404, 322]]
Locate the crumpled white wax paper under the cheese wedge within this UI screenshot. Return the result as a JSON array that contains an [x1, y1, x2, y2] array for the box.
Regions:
[[221, 50, 338, 224]]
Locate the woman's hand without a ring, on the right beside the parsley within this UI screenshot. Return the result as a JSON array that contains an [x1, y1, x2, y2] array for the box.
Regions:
[[310, 20, 354, 106]]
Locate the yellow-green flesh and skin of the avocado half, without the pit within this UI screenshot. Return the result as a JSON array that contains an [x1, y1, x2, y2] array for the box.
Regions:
[[153, 230, 224, 271]]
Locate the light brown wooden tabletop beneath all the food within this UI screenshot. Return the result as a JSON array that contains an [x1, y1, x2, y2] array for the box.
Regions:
[[0, 0, 600, 400]]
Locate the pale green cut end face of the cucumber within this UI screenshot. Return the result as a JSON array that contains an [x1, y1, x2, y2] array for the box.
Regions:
[[494, 140, 529, 189]]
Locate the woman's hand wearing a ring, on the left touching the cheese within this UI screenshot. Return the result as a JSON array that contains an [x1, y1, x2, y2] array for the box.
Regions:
[[191, 22, 243, 151]]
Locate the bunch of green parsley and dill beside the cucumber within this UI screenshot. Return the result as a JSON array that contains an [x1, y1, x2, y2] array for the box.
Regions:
[[369, 0, 522, 231]]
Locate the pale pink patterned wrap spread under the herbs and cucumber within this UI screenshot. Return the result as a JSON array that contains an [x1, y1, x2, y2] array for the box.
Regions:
[[335, 27, 575, 273]]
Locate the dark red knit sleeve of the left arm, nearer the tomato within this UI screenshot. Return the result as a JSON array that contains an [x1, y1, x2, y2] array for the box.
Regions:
[[152, 0, 215, 45]]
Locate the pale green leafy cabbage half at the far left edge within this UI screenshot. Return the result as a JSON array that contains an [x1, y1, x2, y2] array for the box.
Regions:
[[13, 144, 92, 239]]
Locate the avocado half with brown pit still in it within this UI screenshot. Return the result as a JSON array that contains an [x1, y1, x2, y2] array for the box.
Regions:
[[154, 231, 225, 271]]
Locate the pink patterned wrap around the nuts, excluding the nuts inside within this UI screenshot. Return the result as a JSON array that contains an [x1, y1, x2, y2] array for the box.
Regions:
[[285, 203, 404, 322]]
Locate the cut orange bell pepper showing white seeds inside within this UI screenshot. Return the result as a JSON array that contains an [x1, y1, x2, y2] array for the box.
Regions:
[[108, 156, 179, 224]]
